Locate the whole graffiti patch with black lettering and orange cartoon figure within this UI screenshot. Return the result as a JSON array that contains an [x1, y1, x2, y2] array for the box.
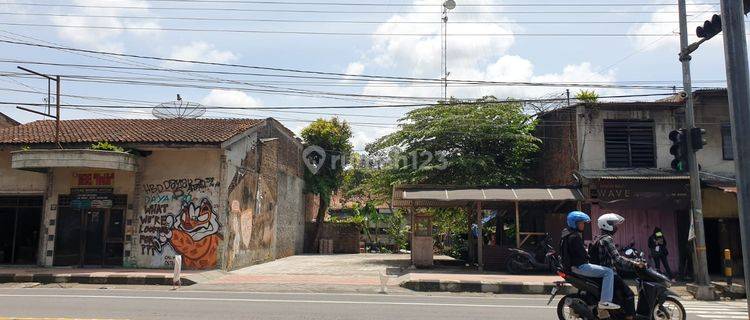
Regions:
[[139, 178, 221, 269]]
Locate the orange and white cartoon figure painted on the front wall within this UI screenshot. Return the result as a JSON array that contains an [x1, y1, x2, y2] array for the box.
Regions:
[[164, 198, 221, 269]]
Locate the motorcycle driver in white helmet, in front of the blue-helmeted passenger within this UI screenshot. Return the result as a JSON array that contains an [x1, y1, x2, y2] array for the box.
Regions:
[[589, 213, 646, 319]]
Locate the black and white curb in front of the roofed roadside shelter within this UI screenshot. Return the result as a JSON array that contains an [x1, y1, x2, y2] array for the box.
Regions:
[[400, 280, 575, 295]]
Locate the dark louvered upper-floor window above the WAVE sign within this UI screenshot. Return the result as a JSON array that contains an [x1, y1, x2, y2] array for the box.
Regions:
[[604, 120, 656, 168]]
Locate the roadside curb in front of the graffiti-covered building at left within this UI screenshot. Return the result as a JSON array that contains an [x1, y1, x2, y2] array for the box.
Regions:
[[0, 273, 196, 286]]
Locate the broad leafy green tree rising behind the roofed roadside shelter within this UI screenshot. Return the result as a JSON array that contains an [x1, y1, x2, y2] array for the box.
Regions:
[[367, 97, 540, 186]]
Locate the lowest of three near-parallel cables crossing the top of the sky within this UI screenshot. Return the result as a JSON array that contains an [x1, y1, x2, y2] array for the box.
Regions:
[[0, 22, 677, 38]]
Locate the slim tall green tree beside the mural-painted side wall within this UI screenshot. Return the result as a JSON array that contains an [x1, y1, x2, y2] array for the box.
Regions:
[[301, 118, 352, 250]]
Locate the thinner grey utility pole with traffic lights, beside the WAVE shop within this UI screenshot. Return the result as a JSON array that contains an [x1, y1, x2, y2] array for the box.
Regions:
[[678, 0, 714, 300]]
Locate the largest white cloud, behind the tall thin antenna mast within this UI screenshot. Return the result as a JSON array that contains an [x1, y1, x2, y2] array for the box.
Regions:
[[358, 0, 615, 104]]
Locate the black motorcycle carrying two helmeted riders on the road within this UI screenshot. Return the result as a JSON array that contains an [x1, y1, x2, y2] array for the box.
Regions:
[[547, 268, 687, 320]]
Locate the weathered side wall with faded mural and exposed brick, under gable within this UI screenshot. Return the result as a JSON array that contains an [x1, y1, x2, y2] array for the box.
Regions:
[[222, 121, 304, 269]]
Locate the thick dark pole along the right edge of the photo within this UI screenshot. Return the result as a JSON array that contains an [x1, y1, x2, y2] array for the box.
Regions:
[[721, 0, 750, 308]]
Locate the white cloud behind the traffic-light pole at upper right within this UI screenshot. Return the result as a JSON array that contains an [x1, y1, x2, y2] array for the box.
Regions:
[[629, 0, 719, 54]]
